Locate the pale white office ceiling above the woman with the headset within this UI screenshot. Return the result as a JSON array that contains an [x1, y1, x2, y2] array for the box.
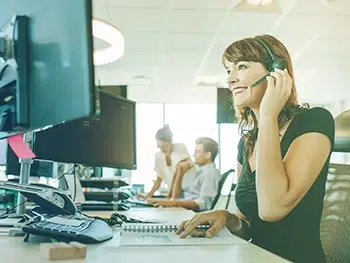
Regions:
[[93, 0, 350, 104]]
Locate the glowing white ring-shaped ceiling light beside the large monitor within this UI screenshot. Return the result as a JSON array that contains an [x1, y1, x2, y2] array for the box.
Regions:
[[92, 18, 125, 66]]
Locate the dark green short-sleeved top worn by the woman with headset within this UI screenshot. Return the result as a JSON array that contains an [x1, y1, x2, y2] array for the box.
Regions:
[[235, 107, 334, 263]]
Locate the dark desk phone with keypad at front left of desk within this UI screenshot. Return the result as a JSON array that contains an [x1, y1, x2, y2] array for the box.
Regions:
[[0, 181, 113, 244]]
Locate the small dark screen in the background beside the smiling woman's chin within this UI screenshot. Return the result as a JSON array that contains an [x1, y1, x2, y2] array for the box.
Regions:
[[216, 88, 237, 123]]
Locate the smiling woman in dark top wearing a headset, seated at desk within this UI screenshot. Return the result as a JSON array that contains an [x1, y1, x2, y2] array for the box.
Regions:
[[177, 35, 334, 263]]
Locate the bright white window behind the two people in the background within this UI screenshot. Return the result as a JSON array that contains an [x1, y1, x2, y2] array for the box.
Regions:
[[132, 103, 240, 194]]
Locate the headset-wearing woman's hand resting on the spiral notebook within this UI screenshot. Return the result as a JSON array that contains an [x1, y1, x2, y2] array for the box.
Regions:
[[176, 210, 232, 238]]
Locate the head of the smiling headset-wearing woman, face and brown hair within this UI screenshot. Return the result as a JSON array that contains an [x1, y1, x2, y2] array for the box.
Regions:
[[222, 36, 304, 159]]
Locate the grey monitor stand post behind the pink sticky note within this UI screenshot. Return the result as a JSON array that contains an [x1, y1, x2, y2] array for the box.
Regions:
[[15, 132, 34, 217]]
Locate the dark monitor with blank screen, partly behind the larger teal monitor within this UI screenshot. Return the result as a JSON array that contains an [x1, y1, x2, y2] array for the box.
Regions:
[[33, 91, 136, 170]]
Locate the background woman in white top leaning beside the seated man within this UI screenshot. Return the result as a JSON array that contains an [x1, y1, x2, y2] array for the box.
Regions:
[[138, 125, 194, 199]]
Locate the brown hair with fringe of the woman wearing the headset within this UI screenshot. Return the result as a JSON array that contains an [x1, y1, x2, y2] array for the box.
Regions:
[[222, 35, 307, 157]]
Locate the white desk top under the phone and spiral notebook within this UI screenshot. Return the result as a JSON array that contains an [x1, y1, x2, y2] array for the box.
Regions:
[[0, 208, 288, 263]]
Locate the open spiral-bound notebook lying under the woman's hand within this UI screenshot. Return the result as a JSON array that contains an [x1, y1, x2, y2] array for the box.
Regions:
[[119, 223, 245, 246]]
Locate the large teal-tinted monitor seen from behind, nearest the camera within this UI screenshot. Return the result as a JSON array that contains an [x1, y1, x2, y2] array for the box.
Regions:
[[0, 0, 96, 138]]
